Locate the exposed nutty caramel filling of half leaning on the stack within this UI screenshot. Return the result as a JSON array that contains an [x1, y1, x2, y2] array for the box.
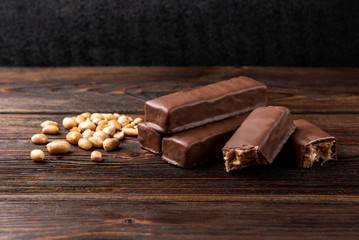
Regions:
[[223, 146, 267, 172]]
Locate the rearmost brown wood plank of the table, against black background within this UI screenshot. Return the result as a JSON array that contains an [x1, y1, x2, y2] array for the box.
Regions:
[[0, 67, 359, 114]]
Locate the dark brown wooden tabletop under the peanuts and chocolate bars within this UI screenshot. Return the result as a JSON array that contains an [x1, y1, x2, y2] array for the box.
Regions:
[[0, 67, 359, 240]]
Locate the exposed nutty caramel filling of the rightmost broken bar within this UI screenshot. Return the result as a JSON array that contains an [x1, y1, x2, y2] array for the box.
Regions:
[[303, 140, 335, 168]]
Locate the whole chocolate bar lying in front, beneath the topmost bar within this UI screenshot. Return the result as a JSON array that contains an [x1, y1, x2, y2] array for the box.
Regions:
[[162, 113, 248, 168]]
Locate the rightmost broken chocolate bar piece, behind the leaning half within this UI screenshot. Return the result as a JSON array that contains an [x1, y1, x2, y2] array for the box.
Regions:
[[290, 119, 337, 168]]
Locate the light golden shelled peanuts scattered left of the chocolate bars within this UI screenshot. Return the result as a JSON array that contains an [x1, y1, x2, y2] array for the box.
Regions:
[[30, 112, 142, 162]]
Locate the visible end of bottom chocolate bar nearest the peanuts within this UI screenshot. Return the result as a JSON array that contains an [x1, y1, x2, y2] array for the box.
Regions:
[[137, 122, 162, 154]]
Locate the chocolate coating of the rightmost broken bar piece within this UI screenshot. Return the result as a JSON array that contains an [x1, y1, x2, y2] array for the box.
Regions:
[[290, 119, 337, 167]]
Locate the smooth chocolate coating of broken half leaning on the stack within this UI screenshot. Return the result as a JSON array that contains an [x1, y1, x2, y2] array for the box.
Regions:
[[223, 106, 295, 164]]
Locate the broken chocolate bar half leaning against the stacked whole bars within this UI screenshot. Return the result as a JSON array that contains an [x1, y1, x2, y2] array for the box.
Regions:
[[222, 106, 295, 172]]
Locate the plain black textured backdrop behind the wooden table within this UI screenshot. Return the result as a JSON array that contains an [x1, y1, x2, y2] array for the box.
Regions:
[[0, 0, 359, 66]]
